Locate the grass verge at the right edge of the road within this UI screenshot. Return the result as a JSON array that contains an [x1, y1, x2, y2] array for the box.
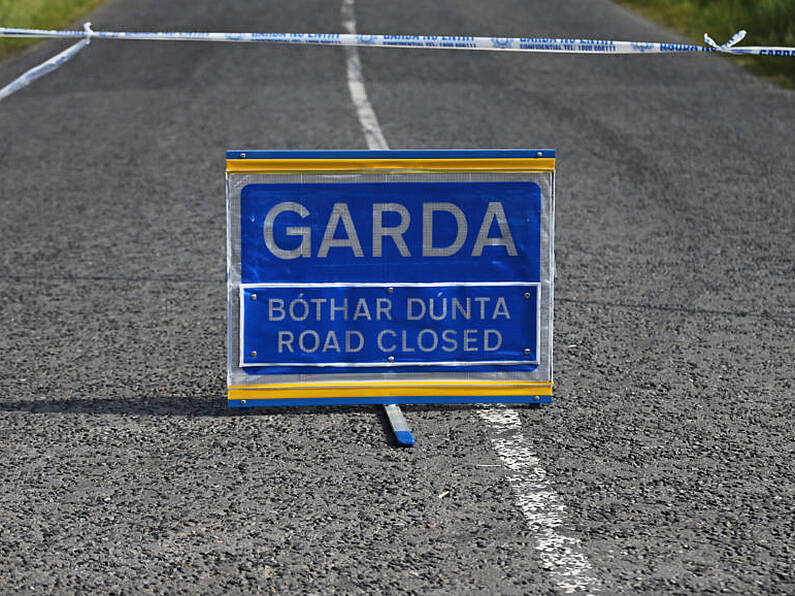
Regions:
[[617, 0, 795, 89]]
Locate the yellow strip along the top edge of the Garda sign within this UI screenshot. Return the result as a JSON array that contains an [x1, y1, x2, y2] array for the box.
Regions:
[[226, 157, 555, 174]]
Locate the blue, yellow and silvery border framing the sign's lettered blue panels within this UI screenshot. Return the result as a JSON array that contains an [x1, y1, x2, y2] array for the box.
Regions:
[[226, 150, 555, 408]]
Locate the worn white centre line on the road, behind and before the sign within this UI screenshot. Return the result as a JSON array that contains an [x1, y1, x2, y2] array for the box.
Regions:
[[341, 0, 599, 594]]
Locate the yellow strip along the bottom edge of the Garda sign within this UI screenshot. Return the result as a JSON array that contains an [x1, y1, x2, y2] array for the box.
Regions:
[[228, 381, 552, 399]]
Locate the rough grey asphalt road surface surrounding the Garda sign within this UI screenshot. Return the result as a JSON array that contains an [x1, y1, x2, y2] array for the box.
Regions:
[[0, 0, 795, 594]]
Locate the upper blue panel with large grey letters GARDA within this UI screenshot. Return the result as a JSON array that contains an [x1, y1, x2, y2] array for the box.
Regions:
[[240, 182, 541, 283]]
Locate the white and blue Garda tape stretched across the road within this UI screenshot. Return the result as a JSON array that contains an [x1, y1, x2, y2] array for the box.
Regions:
[[0, 23, 795, 100]]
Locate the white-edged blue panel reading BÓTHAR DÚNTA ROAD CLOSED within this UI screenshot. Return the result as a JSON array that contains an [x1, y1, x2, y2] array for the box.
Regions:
[[240, 284, 538, 374]]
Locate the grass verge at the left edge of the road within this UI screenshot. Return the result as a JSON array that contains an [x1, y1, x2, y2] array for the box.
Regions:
[[0, 0, 107, 60]]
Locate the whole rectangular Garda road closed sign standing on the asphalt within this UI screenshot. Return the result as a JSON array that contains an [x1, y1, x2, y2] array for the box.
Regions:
[[226, 150, 555, 407]]
